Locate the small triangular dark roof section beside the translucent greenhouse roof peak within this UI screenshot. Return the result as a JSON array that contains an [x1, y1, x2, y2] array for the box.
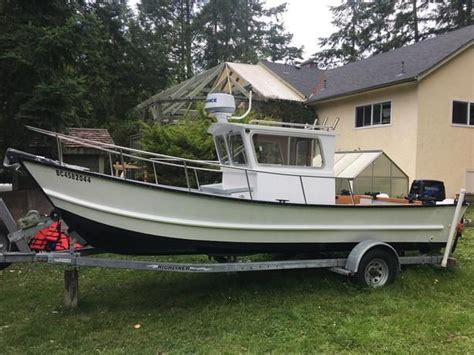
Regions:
[[259, 60, 324, 98]]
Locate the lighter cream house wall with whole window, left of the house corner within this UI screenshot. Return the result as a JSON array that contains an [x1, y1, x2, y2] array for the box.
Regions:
[[316, 82, 418, 181]]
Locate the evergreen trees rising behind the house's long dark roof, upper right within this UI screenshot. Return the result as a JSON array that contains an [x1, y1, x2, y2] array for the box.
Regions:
[[314, 0, 473, 66]]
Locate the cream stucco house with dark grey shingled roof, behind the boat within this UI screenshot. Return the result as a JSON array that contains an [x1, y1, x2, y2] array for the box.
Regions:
[[305, 26, 474, 196]]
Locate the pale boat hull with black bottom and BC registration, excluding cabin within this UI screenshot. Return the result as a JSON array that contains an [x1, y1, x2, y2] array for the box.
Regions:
[[8, 151, 464, 255]]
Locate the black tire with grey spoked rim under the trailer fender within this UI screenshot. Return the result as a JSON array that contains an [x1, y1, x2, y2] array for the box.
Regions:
[[356, 248, 398, 288]]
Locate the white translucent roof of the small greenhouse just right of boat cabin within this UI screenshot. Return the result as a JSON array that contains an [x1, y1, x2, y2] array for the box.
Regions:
[[334, 151, 384, 179]]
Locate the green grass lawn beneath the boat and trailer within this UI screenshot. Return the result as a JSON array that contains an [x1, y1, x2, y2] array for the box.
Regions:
[[0, 209, 474, 354]]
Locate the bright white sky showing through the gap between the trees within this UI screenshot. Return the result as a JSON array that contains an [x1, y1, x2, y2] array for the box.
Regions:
[[128, 0, 340, 59]]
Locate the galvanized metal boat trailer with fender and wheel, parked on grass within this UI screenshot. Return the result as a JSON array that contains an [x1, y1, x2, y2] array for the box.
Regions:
[[0, 190, 465, 308]]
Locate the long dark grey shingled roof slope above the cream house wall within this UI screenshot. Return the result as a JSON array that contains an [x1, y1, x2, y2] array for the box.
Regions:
[[307, 25, 474, 103]]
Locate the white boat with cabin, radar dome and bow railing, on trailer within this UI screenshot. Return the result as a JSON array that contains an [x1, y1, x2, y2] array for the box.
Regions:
[[4, 94, 466, 255]]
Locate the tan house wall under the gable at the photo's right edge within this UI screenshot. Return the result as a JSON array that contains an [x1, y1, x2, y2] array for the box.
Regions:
[[416, 46, 474, 196]]
